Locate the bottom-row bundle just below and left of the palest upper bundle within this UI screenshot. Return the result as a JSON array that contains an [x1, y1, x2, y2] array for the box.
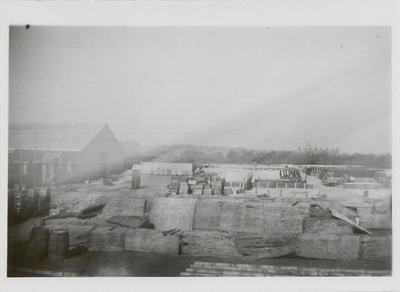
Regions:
[[125, 229, 179, 255]]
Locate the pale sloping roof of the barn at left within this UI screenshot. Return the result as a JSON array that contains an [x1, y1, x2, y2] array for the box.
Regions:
[[8, 124, 107, 151]]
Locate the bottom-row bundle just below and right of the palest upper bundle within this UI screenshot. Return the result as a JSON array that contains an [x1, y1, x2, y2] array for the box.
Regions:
[[182, 231, 241, 257]]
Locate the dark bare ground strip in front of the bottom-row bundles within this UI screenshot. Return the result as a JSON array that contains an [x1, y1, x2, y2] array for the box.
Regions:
[[8, 250, 391, 277]]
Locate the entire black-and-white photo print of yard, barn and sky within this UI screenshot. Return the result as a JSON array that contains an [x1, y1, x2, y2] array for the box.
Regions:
[[1, 1, 398, 291]]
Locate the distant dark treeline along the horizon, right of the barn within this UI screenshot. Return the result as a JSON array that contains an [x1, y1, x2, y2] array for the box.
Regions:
[[121, 142, 392, 168]]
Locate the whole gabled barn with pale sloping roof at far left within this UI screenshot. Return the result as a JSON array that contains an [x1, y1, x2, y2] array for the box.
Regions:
[[8, 124, 123, 188]]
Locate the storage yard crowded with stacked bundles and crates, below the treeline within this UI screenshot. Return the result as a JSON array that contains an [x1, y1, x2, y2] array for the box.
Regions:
[[8, 163, 392, 276]]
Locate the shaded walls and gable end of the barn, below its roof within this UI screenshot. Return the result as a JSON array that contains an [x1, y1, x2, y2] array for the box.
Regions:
[[8, 126, 124, 188]]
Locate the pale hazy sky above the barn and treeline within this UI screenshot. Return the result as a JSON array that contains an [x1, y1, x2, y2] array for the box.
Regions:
[[10, 26, 391, 153]]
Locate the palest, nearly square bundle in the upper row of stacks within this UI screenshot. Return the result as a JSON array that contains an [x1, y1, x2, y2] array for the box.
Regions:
[[150, 197, 197, 230]]
